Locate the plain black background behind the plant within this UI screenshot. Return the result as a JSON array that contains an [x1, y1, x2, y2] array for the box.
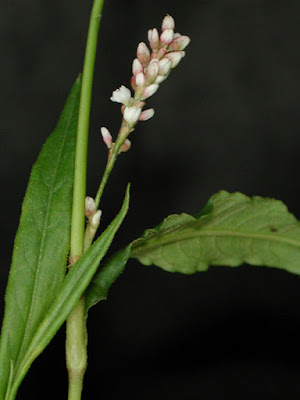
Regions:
[[0, 0, 300, 400]]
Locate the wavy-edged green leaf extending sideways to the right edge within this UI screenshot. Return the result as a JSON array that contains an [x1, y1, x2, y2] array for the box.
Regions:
[[131, 191, 300, 274]]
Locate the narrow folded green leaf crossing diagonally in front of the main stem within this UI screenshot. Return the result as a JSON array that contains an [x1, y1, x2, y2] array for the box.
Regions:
[[6, 186, 129, 400]]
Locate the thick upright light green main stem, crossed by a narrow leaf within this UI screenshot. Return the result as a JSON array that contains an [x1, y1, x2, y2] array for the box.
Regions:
[[66, 0, 104, 400]]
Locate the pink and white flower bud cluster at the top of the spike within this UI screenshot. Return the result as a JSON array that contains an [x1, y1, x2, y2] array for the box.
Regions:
[[101, 15, 190, 151]]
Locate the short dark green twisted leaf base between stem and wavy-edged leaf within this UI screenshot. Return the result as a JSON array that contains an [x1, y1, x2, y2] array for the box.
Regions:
[[85, 245, 131, 311]]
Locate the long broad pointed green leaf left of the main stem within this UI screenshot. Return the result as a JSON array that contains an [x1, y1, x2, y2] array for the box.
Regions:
[[0, 78, 81, 399]]
